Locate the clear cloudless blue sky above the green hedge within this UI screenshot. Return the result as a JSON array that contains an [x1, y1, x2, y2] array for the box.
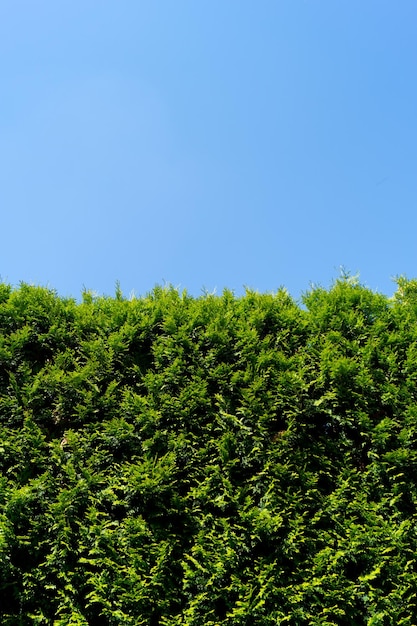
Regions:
[[0, 0, 417, 298]]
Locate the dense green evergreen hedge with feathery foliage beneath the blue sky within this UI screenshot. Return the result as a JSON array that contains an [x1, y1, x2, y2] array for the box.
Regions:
[[0, 278, 417, 626]]
